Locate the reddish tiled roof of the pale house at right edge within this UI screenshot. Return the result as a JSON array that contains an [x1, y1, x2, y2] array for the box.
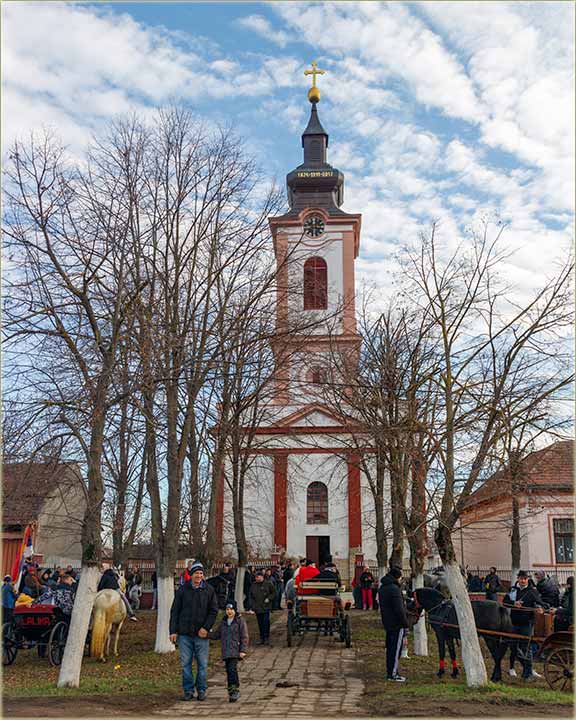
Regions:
[[464, 440, 574, 509]]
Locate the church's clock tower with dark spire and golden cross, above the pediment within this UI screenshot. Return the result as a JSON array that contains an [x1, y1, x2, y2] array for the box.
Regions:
[[269, 63, 361, 404]]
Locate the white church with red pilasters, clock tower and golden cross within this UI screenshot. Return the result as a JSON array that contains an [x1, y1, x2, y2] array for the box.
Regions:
[[220, 63, 376, 578]]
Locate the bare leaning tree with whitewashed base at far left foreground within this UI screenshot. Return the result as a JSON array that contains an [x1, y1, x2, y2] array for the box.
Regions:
[[4, 129, 144, 687]]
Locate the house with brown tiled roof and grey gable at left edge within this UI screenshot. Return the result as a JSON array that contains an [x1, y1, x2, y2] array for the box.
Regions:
[[2, 462, 86, 576]]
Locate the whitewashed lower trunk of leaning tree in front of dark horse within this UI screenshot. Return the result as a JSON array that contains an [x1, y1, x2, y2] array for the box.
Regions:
[[444, 563, 488, 687]]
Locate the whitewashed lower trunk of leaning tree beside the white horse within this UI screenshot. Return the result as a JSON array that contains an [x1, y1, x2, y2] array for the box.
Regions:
[[58, 566, 100, 687]]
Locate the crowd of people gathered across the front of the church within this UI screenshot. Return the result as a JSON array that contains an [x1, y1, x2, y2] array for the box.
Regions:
[[2, 559, 574, 702]]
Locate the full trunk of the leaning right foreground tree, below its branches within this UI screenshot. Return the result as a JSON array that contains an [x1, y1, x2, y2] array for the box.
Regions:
[[436, 525, 488, 687]]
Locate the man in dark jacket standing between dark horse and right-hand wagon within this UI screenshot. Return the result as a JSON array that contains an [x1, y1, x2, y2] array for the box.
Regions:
[[503, 570, 544, 682]]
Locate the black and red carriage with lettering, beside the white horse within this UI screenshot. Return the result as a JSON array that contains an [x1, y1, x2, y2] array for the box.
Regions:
[[2, 605, 70, 666]]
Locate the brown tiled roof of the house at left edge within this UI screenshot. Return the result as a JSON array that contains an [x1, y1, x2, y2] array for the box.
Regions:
[[2, 462, 82, 526]]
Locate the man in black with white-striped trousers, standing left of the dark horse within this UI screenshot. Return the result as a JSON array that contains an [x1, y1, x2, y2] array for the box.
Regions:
[[378, 567, 408, 682]]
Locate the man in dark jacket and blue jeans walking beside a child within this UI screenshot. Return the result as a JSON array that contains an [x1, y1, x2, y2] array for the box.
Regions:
[[170, 562, 218, 701]]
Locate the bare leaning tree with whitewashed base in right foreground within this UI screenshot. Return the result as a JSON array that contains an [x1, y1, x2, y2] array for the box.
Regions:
[[406, 219, 571, 686]]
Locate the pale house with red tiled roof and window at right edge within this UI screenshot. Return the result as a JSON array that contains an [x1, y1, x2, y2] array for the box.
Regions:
[[454, 440, 574, 573]]
